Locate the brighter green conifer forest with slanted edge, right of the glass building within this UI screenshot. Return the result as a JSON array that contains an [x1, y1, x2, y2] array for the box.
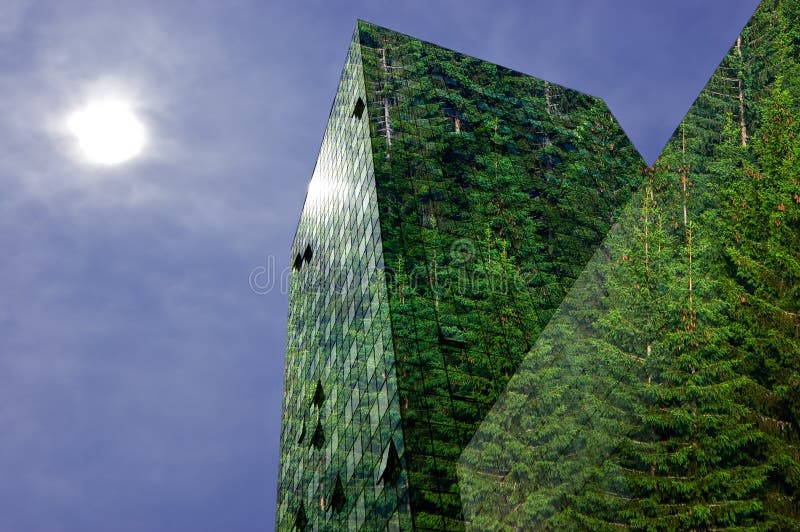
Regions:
[[459, 1, 800, 530]]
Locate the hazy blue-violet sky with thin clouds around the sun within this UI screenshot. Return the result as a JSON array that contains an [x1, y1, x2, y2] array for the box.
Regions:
[[0, 0, 758, 532]]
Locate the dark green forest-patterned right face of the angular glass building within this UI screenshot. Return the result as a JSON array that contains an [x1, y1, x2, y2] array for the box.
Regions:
[[360, 19, 643, 530]]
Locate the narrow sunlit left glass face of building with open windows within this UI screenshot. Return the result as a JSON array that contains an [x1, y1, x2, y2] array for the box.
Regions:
[[277, 33, 409, 530]]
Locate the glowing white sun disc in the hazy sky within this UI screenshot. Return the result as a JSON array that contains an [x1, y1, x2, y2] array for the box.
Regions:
[[67, 100, 147, 165]]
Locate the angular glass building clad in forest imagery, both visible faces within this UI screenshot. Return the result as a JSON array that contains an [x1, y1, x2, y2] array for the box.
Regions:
[[277, 18, 645, 531]]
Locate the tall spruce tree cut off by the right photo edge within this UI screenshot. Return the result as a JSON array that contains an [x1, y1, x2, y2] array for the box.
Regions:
[[725, 78, 800, 525]]
